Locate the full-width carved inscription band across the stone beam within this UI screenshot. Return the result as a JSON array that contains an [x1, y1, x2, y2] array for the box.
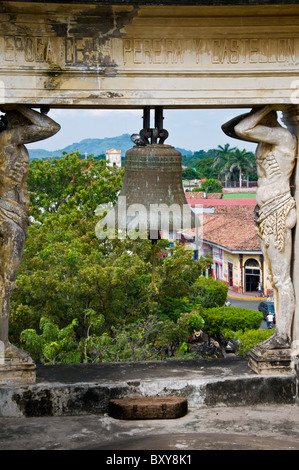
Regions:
[[0, 35, 299, 71]]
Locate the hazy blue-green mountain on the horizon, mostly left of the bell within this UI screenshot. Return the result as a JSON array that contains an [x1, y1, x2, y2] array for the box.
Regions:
[[28, 134, 193, 159]]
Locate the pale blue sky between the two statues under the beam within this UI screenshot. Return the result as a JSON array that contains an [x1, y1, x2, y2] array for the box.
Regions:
[[27, 108, 256, 152]]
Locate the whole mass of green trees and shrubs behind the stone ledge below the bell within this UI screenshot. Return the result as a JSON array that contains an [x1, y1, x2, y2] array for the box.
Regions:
[[10, 152, 268, 363]]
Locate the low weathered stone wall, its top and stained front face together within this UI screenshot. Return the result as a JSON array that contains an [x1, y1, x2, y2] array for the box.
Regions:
[[0, 359, 298, 417]]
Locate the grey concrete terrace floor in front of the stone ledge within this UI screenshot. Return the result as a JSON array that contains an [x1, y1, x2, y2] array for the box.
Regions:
[[0, 405, 299, 453]]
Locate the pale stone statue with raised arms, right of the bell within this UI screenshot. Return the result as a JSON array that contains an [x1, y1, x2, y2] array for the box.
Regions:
[[222, 105, 297, 350]]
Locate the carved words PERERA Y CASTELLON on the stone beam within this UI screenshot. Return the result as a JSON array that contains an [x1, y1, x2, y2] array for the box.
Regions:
[[123, 38, 298, 66]]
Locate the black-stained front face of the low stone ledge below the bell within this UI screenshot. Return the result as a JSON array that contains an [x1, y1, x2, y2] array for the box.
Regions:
[[0, 374, 296, 417]]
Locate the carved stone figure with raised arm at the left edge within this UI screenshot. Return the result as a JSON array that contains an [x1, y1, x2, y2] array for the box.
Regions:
[[0, 106, 60, 362]]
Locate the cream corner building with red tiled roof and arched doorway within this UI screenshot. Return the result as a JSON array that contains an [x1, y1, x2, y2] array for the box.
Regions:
[[180, 201, 273, 296]]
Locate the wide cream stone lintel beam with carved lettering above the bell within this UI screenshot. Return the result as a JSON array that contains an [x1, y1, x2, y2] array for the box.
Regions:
[[0, 0, 299, 382]]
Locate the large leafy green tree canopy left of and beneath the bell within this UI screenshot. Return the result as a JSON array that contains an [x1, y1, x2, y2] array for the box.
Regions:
[[10, 153, 216, 348]]
